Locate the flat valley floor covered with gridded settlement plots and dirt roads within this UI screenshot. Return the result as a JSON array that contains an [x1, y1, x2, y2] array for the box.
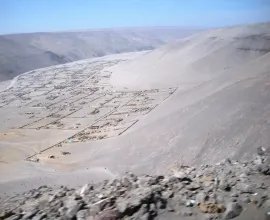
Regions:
[[0, 52, 180, 193]]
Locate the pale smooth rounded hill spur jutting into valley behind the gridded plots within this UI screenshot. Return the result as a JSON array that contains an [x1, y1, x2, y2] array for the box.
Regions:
[[112, 23, 270, 88]]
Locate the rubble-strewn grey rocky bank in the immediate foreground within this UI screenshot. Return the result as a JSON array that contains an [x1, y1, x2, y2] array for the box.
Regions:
[[0, 147, 270, 220]]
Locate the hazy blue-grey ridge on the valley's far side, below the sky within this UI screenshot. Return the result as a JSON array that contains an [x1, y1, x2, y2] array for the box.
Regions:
[[0, 27, 199, 81]]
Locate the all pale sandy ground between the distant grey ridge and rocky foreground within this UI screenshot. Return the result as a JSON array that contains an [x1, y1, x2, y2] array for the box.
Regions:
[[0, 23, 270, 196]]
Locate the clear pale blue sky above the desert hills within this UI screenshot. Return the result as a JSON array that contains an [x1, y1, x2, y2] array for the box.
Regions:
[[0, 0, 270, 34]]
